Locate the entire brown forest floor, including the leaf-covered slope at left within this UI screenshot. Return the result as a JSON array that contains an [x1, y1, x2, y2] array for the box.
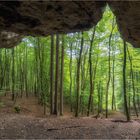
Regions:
[[0, 94, 140, 139]]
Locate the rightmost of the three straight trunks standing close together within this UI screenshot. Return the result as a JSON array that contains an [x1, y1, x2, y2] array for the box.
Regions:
[[60, 36, 64, 115]]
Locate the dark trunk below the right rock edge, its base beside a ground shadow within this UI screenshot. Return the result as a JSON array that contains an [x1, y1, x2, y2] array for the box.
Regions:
[[123, 41, 130, 121]]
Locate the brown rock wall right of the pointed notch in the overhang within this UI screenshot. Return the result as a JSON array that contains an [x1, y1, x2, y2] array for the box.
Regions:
[[109, 1, 140, 48]]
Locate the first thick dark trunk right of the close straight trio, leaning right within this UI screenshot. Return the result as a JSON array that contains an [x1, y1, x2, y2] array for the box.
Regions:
[[75, 32, 84, 117]]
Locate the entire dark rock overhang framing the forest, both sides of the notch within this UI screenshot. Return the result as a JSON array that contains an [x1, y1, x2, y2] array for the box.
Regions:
[[0, 0, 140, 48]]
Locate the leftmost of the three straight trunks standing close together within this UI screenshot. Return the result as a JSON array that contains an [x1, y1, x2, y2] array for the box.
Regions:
[[50, 35, 54, 114]]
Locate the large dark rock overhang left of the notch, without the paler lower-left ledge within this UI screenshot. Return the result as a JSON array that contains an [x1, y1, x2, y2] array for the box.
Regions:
[[0, 1, 105, 35]]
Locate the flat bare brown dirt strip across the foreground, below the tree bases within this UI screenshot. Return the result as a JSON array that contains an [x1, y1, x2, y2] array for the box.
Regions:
[[0, 114, 140, 139]]
